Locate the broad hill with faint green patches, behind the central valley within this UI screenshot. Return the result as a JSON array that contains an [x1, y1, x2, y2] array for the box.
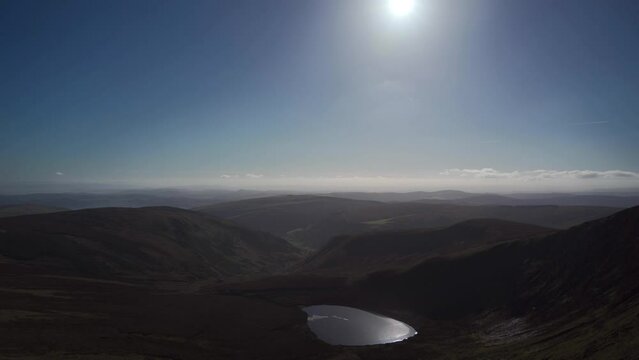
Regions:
[[197, 195, 618, 249]]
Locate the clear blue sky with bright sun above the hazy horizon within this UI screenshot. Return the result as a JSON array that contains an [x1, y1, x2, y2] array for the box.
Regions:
[[0, 0, 639, 190]]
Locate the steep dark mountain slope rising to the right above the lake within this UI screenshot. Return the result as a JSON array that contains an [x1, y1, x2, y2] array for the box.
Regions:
[[361, 207, 639, 318]]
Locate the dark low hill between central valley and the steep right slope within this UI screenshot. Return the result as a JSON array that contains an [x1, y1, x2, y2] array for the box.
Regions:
[[301, 219, 554, 275]]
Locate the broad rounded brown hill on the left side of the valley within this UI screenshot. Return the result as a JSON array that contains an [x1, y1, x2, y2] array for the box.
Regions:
[[0, 207, 300, 279]]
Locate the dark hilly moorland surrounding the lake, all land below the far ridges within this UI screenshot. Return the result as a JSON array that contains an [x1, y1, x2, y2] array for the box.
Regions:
[[0, 195, 639, 360]]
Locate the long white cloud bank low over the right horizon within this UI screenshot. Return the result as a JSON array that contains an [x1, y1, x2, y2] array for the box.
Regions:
[[440, 168, 639, 180]]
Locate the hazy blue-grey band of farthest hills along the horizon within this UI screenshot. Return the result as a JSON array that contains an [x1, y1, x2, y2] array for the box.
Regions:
[[0, 189, 639, 210]]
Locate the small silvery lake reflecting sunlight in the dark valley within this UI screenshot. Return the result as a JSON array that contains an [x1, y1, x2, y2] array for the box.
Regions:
[[303, 305, 417, 346]]
